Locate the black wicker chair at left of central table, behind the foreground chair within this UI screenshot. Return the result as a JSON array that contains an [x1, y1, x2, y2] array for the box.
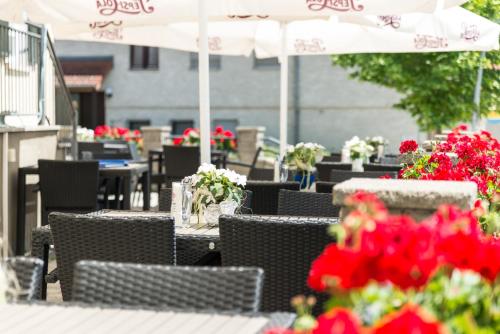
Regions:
[[49, 212, 175, 301]]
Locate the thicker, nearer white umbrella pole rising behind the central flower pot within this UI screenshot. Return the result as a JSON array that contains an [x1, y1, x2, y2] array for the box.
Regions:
[[198, 0, 211, 163]]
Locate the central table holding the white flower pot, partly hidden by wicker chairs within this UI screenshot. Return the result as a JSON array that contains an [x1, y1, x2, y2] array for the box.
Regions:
[[31, 210, 220, 299]]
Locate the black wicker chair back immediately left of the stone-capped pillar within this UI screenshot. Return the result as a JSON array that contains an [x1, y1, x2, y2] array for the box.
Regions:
[[278, 189, 340, 217]]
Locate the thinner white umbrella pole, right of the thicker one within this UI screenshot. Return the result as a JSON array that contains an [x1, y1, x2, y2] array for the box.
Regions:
[[280, 22, 288, 159]]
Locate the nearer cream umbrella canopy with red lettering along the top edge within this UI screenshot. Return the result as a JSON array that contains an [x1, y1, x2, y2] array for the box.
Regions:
[[0, 0, 467, 25]]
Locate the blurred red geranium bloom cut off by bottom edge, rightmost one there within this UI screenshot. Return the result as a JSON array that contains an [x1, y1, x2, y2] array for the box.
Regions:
[[372, 305, 444, 334]]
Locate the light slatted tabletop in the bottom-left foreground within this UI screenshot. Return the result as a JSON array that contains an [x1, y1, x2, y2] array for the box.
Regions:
[[0, 303, 294, 334]]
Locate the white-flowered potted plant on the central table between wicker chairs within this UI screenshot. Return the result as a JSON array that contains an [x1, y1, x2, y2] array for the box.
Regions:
[[191, 164, 247, 225]]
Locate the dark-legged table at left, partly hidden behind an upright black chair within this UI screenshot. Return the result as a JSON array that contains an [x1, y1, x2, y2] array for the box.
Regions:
[[16, 163, 150, 255]]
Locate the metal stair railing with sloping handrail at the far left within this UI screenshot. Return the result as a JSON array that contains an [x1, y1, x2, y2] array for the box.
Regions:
[[0, 21, 77, 158]]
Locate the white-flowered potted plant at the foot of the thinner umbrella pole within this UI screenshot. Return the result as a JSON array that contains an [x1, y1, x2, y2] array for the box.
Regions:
[[286, 143, 326, 190]]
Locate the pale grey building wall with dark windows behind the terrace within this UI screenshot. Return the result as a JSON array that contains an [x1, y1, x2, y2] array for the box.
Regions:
[[56, 41, 421, 152]]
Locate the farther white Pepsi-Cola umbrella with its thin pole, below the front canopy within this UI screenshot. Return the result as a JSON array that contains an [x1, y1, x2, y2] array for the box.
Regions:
[[47, 7, 500, 154]]
